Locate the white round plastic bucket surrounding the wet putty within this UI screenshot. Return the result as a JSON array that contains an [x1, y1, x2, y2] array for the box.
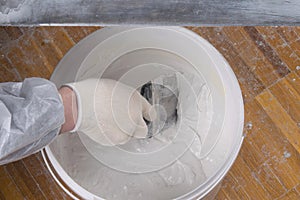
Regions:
[[42, 27, 244, 199]]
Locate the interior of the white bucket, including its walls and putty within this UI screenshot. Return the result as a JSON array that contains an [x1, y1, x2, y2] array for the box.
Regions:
[[47, 27, 243, 199]]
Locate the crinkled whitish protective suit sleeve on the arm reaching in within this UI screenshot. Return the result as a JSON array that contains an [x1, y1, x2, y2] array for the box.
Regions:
[[0, 78, 65, 165]]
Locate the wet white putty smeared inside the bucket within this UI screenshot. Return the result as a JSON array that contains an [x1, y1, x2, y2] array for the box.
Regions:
[[55, 70, 212, 199]]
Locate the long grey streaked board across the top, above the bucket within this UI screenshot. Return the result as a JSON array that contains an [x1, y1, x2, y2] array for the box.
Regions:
[[0, 0, 300, 25]]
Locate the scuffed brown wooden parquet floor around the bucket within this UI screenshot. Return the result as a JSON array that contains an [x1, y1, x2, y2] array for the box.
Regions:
[[0, 27, 300, 200]]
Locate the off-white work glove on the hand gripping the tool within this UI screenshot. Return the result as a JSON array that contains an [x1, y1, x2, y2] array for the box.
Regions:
[[66, 79, 156, 146]]
